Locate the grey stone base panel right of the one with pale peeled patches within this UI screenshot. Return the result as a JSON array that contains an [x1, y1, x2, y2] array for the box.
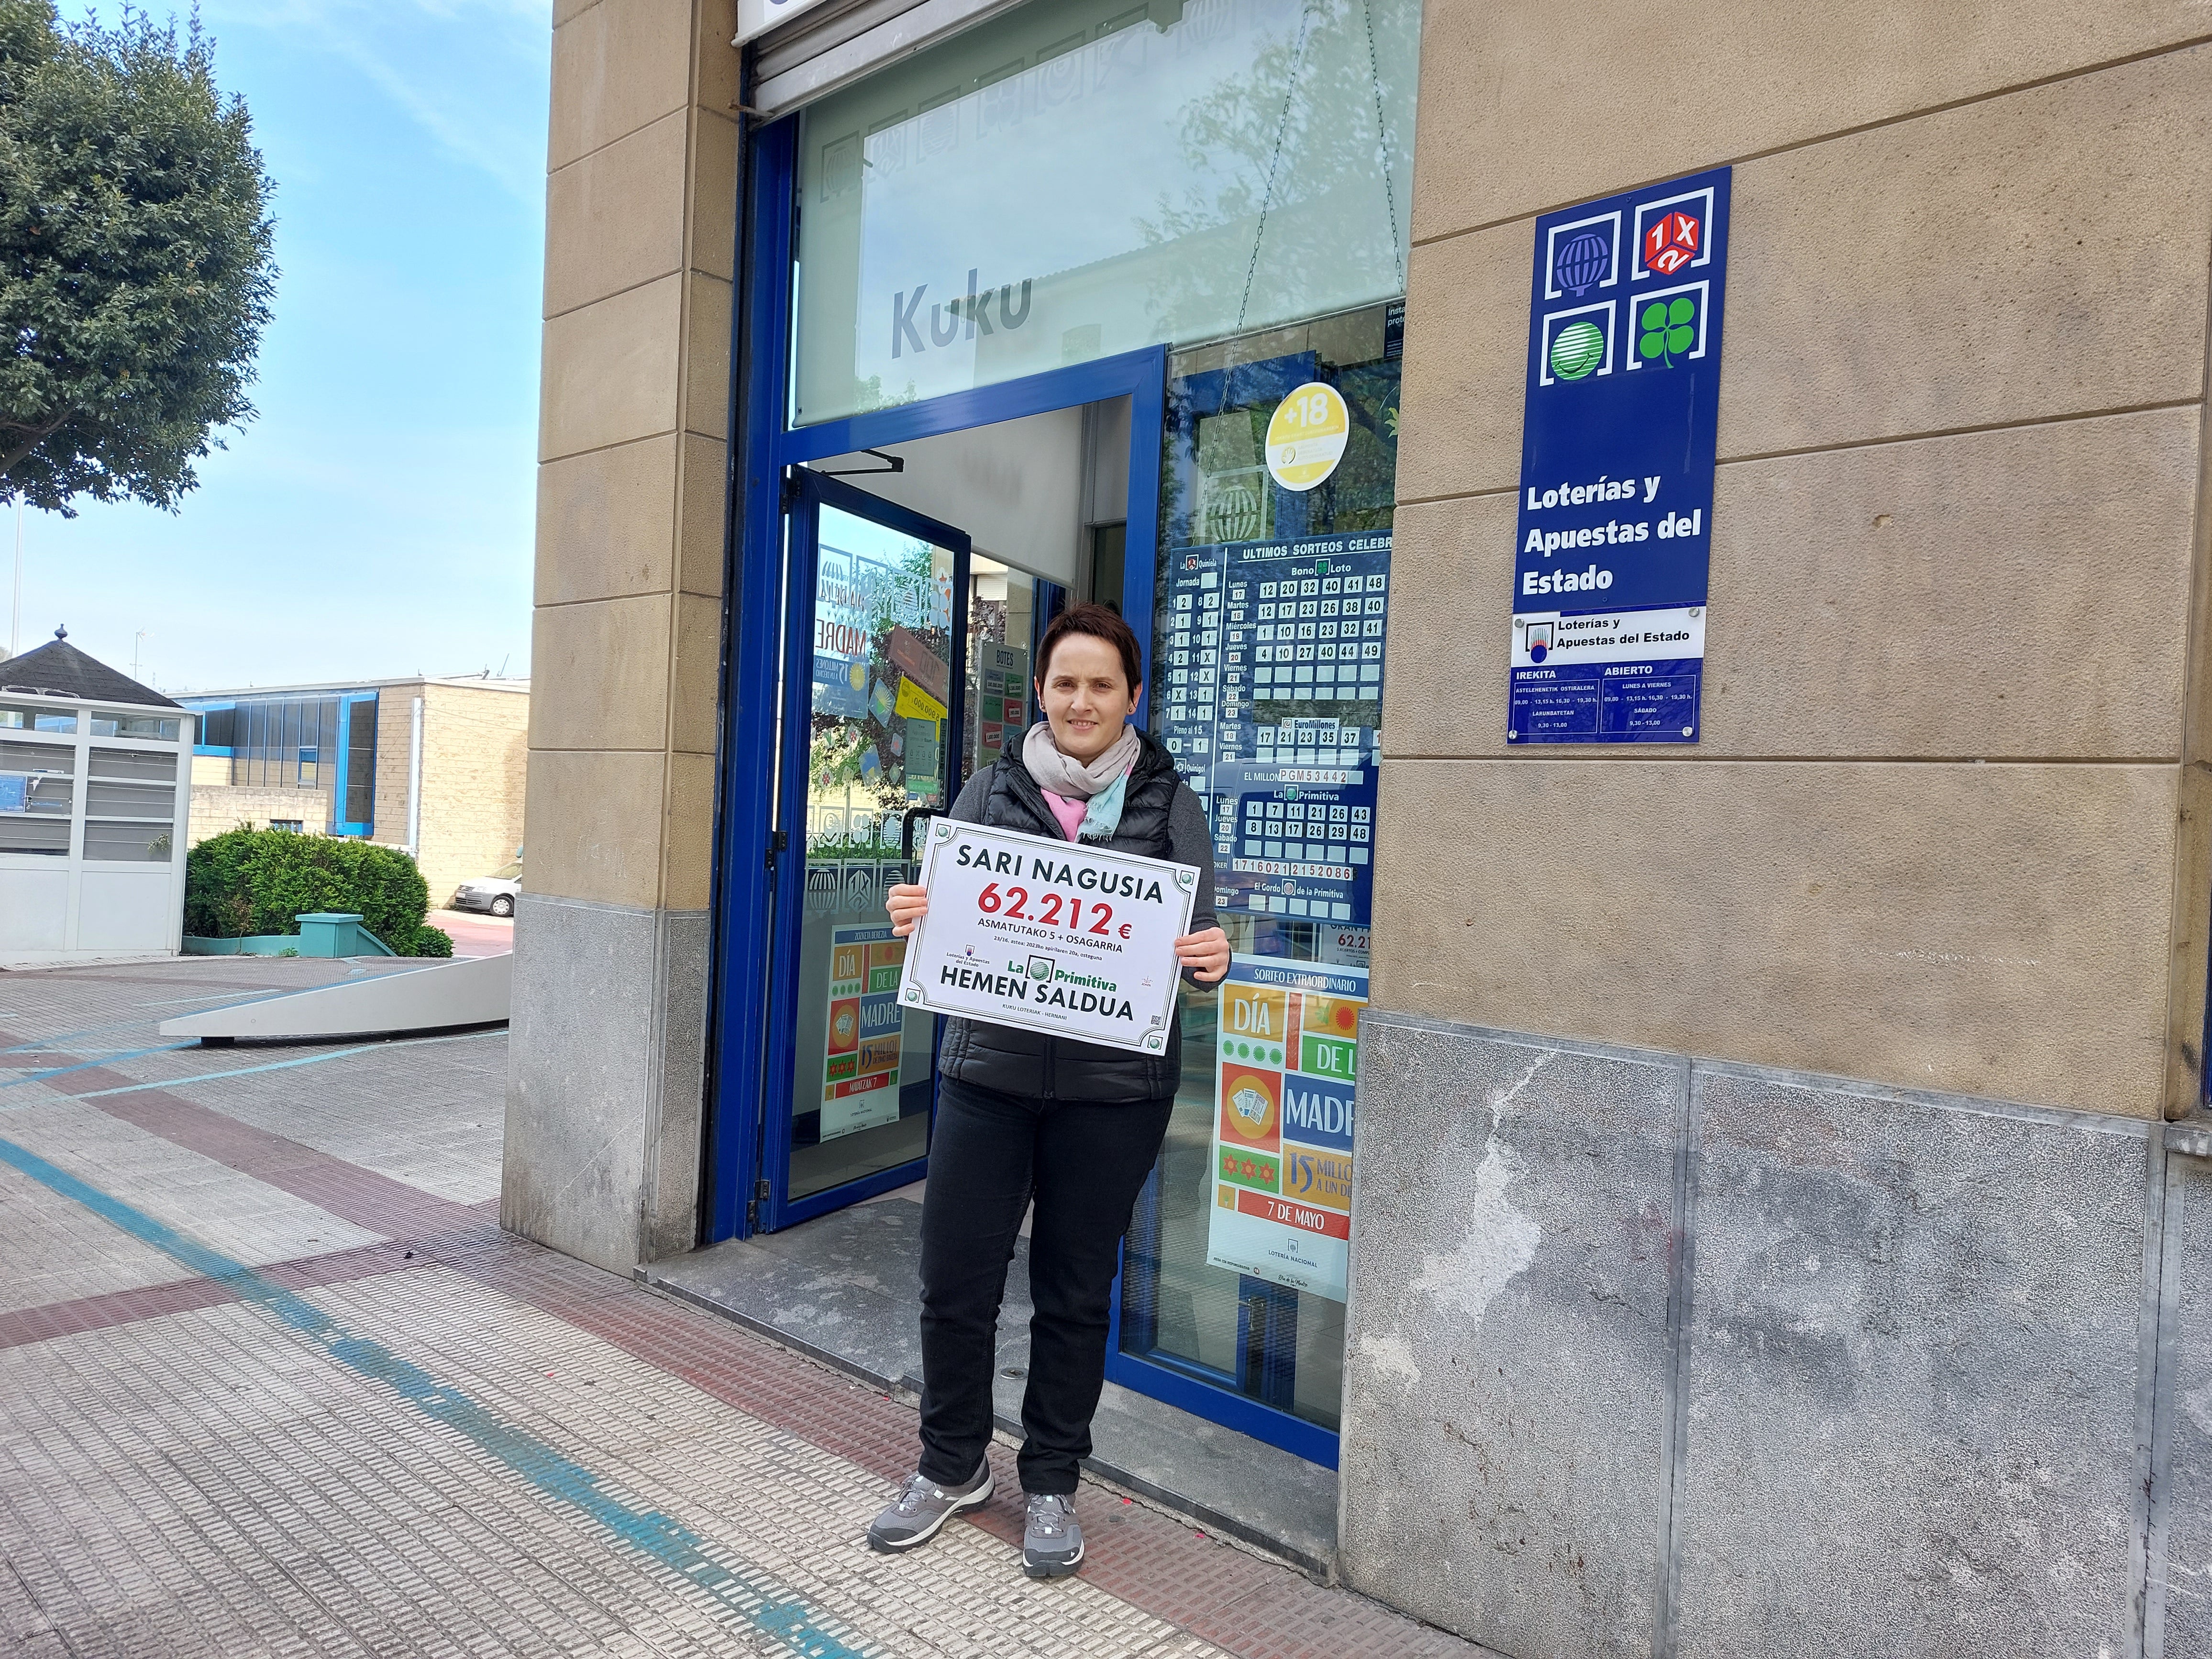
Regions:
[[1674, 1066, 2141, 1659]]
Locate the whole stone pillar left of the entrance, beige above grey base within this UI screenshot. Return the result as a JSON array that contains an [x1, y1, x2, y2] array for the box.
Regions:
[[502, 0, 739, 1270]]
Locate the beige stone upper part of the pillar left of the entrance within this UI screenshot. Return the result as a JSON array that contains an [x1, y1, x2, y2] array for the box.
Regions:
[[529, 0, 737, 929]]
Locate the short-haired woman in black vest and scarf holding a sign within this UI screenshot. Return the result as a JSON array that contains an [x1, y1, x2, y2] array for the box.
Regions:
[[867, 604, 1230, 1577]]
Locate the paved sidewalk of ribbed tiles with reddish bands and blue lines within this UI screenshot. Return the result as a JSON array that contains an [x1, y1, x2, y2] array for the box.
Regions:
[[0, 958, 1480, 1659]]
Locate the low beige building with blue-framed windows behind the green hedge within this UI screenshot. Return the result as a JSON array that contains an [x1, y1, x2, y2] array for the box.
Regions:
[[181, 677, 531, 907]]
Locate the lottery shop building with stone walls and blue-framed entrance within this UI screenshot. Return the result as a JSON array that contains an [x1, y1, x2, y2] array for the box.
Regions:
[[502, 0, 2212, 1659]]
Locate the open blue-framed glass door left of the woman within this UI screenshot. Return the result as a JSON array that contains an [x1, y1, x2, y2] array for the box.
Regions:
[[761, 469, 969, 1230]]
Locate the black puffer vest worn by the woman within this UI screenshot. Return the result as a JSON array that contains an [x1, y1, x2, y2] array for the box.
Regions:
[[938, 732, 1183, 1102]]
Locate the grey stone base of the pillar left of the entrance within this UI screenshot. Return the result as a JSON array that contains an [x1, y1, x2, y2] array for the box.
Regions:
[[500, 894, 708, 1274]]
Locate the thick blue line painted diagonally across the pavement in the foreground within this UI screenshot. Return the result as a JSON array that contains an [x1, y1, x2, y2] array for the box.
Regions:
[[0, 1139, 867, 1659]]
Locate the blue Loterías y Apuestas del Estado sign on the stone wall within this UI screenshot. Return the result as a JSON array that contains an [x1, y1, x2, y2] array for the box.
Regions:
[[1506, 168, 1730, 743]]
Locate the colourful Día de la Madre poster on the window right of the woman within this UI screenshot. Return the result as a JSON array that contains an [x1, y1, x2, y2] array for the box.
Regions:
[[1206, 956, 1367, 1303]]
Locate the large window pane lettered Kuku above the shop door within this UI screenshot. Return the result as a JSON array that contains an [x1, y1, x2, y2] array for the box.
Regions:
[[792, 0, 1420, 429]]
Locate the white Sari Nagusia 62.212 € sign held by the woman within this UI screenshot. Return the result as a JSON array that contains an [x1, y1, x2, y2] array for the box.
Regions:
[[898, 818, 1199, 1055]]
